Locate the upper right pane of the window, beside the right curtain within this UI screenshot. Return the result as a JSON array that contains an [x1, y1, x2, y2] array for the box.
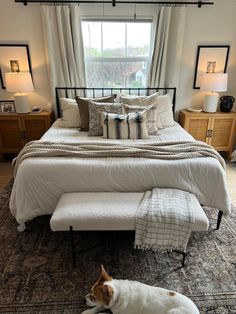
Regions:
[[127, 23, 151, 57]]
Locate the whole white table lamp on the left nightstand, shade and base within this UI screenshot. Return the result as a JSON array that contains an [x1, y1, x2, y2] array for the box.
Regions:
[[5, 72, 34, 113]]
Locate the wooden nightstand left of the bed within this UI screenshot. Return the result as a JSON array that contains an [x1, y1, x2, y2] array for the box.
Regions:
[[0, 111, 52, 160]]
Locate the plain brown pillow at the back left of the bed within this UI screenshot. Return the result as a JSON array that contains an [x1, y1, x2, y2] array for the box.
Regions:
[[75, 94, 116, 131]]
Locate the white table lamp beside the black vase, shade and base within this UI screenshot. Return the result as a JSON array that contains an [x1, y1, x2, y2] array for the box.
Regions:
[[200, 73, 228, 112]]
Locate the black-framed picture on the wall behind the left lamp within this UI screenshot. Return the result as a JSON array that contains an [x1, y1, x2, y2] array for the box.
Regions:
[[0, 44, 32, 89]]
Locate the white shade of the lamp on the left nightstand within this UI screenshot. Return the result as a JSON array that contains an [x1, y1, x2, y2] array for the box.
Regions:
[[5, 72, 34, 93]]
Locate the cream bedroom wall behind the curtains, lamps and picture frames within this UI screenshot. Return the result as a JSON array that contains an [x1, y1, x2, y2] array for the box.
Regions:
[[0, 0, 236, 110]]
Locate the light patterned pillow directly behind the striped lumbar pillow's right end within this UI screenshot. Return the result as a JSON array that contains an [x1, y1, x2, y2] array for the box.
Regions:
[[123, 104, 162, 135]]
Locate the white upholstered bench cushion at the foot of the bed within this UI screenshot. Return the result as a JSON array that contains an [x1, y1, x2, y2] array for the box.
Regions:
[[50, 192, 209, 231]]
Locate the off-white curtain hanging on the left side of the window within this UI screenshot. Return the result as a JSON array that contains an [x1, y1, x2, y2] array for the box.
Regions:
[[41, 5, 86, 111]]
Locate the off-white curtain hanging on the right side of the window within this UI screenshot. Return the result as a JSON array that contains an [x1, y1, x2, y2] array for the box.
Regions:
[[147, 7, 187, 87]]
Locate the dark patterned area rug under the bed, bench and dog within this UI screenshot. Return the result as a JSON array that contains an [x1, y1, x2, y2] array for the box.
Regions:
[[0, 184, 236, 314]]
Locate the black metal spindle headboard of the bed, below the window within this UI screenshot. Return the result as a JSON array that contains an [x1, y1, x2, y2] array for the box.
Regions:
[[55, 87, 176, 118]]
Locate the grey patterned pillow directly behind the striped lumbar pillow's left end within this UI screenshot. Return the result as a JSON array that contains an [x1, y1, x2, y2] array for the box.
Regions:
[[89, 101, 122, 136]]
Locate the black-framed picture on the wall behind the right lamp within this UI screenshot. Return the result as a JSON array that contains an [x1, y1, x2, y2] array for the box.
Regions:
[[193, 45, 230, 89]]
